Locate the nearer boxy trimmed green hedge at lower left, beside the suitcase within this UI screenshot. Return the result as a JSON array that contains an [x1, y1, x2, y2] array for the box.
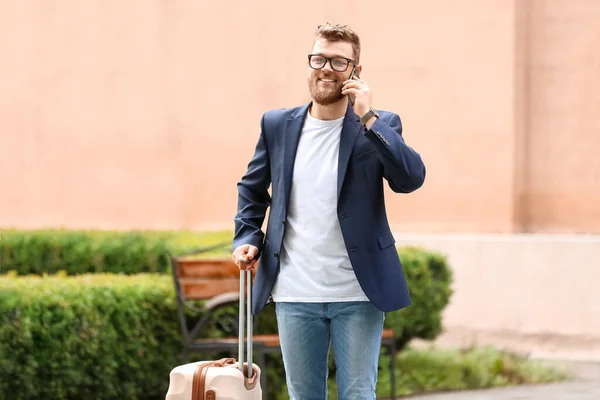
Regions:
[[0, 274, 180, 400]]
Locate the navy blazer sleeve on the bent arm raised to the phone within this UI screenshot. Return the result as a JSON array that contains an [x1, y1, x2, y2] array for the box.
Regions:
[[365, 113, 425, 193]]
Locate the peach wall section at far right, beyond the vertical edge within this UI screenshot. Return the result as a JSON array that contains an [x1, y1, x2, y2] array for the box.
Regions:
[[525, 0, 600, 233]]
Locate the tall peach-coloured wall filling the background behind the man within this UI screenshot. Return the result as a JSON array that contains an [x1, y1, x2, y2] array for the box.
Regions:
[[0, 0, 600, 233]]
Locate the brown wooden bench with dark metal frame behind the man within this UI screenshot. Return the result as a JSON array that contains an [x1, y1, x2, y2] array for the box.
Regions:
[[169, 250, 396, 399]]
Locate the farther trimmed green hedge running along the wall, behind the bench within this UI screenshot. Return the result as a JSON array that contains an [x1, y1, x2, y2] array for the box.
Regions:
[[0, 230, 231, 275]]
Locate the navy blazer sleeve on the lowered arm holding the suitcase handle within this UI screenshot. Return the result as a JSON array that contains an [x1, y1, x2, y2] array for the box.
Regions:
[[233, 115, 271, 254]]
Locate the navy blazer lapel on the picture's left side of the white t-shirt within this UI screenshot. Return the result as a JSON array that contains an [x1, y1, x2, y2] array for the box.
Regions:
[[283, 103, 310, 215]]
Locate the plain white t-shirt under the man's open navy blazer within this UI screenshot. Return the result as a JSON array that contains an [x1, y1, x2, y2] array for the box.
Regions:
[[271, 113, 368, 302]]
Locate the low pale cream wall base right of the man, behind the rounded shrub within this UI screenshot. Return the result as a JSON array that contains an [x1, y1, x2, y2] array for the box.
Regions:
[[396, 234, 600, 360]]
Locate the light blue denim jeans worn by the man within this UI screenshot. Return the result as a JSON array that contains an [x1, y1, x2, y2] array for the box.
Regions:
[[275, 301, 384, 400]]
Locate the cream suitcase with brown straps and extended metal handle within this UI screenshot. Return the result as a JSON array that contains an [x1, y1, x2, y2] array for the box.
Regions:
[[166, 270, 262, 400]]
